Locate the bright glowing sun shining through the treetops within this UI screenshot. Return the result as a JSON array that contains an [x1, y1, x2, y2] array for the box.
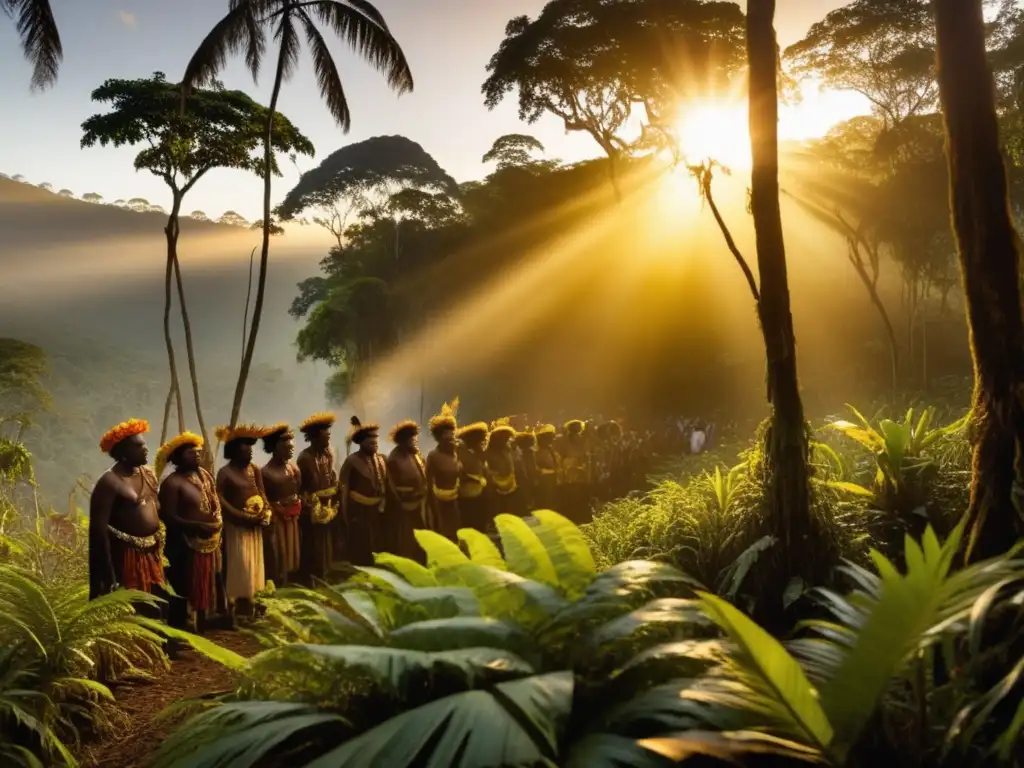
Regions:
[[675, 99, 751, 169]]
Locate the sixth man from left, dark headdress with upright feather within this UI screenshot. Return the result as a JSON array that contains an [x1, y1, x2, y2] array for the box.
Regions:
[[338, 416, 388, 566]]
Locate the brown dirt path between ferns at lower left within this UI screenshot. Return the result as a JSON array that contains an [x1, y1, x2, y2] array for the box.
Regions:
[[79, 630, 260, 768]]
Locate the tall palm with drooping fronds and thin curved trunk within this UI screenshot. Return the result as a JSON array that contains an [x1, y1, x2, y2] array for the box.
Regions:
[[181, 0, 413, 426]]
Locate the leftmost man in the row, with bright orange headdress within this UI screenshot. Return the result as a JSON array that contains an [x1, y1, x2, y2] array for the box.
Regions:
[[89, 419, 164, 600]]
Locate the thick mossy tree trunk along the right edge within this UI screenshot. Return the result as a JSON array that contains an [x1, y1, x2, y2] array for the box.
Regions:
[[934, 0, 1024, 562]]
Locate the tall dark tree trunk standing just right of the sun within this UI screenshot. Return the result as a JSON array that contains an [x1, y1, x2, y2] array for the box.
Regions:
[[746, 0, 811, 574]]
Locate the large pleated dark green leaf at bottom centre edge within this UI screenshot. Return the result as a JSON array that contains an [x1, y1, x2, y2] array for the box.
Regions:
[[306, 672, 572, 768]]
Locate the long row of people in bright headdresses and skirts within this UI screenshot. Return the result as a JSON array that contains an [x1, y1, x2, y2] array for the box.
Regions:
[[89, 400, 646, 631]]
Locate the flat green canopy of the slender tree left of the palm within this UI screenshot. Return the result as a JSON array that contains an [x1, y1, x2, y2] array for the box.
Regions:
[[82, 72, 314, 196]]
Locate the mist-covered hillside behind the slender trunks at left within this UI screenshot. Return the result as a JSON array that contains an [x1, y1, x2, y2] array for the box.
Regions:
[[0, 179, 327, 495]]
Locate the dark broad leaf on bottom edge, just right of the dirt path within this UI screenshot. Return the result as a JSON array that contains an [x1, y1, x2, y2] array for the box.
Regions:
[[152, 701, 351, 768]]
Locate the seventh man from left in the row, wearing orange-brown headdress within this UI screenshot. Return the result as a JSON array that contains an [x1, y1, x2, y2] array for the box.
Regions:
[[387, 419, 427, 560]]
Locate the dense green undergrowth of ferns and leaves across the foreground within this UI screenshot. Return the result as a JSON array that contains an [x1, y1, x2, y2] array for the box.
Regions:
[[0, 409, 1024, 768]]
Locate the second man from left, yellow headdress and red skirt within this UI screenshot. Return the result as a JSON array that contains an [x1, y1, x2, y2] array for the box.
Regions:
[[155, 432, 223, 632]]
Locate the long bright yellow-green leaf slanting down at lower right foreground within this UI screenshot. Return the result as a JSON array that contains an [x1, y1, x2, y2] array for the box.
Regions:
[[690, 593, 833, 752]]
